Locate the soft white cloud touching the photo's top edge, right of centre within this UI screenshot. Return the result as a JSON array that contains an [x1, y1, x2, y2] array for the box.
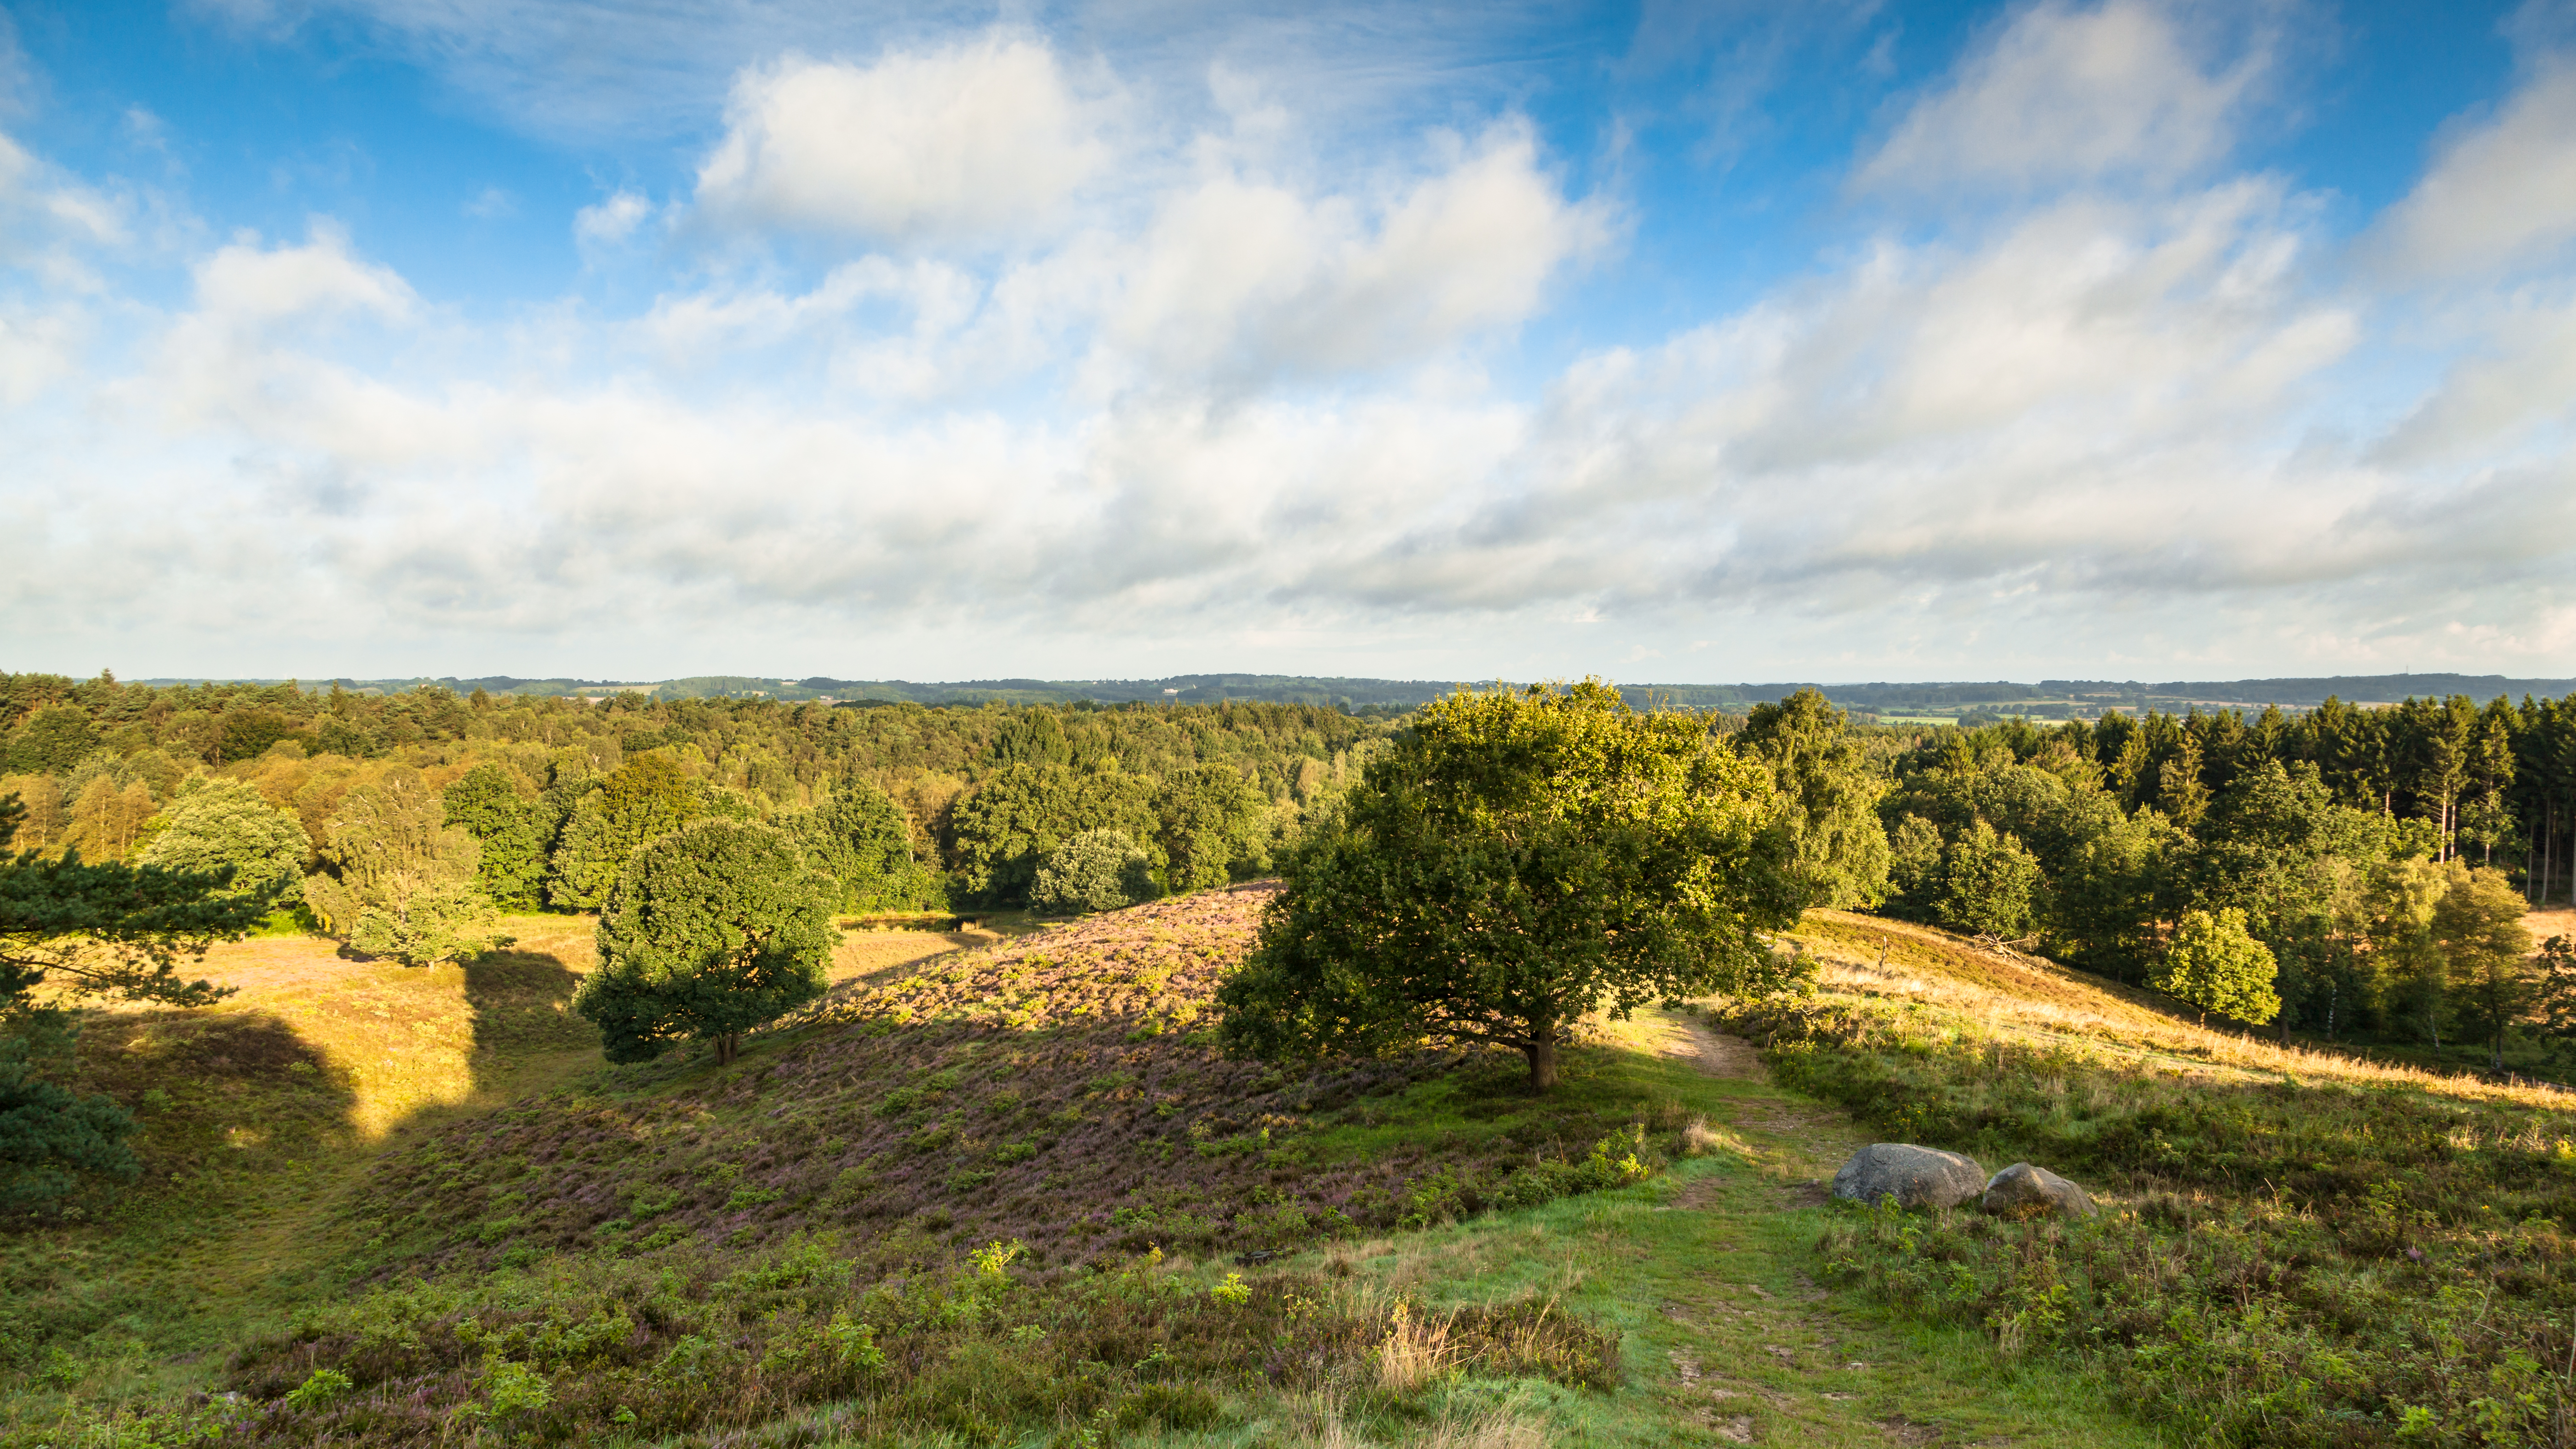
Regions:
[[1855, 0, 2264, 194]]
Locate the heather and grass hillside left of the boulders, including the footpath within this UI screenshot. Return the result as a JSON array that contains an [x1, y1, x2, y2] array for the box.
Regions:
[[0, 889, 2194, 1449]]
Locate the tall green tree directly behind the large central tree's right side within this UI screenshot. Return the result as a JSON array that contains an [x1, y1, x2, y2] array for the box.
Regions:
[[1736, 688, 1891, 908]]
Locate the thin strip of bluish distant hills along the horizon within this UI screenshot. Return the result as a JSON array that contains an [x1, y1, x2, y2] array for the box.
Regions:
[[126, 673, 2576, 725]]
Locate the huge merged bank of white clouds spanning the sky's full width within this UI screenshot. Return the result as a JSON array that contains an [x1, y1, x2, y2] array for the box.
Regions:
[[15, 5, 2576, 676]]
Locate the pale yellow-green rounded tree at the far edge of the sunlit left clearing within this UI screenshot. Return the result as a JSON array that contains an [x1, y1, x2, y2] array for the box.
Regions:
[[304, 768, 492, 967]]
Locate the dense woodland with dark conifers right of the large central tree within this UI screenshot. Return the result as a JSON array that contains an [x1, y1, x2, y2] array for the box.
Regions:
[[1792, 696, 2576, 1052]]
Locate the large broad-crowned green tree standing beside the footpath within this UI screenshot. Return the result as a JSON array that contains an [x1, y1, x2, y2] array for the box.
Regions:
[[1219, 681, 1801, 1091]]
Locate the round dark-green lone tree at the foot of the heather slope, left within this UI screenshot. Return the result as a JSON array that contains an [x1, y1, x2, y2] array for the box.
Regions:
[[574, 820, 837, 1062]]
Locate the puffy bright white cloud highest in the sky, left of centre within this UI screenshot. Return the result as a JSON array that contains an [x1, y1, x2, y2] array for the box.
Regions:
[[698, 31, 1110, 242]]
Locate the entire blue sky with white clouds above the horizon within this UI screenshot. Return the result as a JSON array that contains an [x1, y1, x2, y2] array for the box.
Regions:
[[0, 0, 2576, 683]]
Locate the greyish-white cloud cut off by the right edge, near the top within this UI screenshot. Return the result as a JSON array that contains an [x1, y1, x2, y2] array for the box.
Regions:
[[2380, 64, 2576, 276]]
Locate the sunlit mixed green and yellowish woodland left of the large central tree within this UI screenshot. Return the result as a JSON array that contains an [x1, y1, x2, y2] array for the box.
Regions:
[[0, 676, 1394, 928]]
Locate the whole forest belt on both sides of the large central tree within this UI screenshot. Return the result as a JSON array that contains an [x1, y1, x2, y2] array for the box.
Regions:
[[0, 673, 2576, 1060]]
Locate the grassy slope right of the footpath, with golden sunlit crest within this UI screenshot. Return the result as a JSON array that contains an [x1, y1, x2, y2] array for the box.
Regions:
[[1718, 913, 2576, 1446]]
